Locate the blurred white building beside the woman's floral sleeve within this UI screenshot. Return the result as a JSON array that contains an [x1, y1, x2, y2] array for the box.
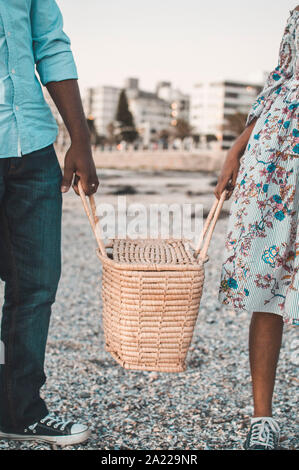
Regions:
[[191, 81, 262, 149]]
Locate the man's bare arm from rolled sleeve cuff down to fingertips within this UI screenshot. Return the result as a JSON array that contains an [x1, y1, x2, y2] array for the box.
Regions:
[[46, 80, 99, 195]]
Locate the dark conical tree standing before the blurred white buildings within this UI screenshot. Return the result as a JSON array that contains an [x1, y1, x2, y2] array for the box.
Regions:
[[116, 90, 138, 143]]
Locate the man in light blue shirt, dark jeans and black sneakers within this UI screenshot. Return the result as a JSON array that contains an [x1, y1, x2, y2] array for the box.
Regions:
[[0, 0, 98, 445]]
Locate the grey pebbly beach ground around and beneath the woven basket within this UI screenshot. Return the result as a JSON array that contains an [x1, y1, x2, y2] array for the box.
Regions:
[[0, 172, 299, 450]]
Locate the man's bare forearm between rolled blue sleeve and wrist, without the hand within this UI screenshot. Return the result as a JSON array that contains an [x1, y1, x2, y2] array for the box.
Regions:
[[46, 80, 90, 144]]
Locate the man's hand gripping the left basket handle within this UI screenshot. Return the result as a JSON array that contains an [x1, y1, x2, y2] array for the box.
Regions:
[[61, 142, 99, 196]]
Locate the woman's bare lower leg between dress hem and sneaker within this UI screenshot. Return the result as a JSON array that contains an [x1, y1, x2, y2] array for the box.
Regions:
[[249, 312, 283, 417]]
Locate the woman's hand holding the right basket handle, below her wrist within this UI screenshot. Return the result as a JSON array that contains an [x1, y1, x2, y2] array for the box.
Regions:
[[214, 149, 240, 199]]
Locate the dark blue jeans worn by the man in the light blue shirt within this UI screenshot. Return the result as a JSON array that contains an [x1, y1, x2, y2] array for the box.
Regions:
[[0, 145, 62, 431]]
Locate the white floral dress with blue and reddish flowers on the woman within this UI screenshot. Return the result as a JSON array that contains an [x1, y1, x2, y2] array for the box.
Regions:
[[219, 10, 299, 325]]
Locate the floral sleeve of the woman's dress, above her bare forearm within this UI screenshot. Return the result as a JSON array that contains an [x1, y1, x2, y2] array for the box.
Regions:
[[246, 12, 296, 125]]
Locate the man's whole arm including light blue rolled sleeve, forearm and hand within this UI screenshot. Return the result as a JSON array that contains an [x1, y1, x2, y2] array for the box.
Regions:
[[30, 0, 99, 194]]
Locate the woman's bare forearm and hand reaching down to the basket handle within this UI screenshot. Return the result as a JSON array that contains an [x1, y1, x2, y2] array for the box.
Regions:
[[214, 119, 256, 199]]
